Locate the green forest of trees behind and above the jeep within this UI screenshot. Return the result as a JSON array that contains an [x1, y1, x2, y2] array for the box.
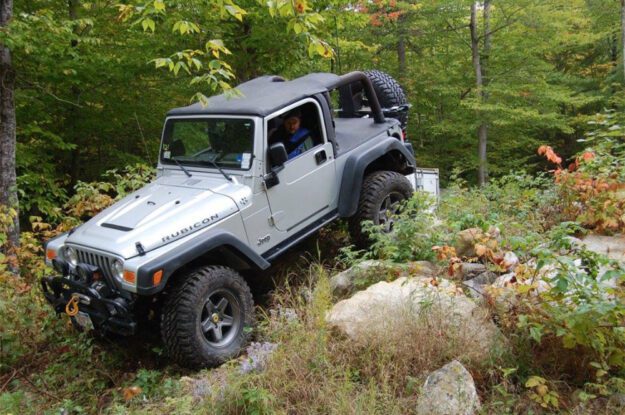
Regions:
[[0, 0, 625, 231]]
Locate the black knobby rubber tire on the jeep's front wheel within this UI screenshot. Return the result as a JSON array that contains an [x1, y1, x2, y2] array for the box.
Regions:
[[161, 266, 254, 368]]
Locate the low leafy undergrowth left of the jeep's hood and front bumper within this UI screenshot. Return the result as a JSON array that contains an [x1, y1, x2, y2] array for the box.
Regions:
[[0, 166, 166, 414]]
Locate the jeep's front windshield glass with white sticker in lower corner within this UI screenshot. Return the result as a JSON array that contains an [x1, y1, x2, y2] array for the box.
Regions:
[[161, 118, 254, 170]]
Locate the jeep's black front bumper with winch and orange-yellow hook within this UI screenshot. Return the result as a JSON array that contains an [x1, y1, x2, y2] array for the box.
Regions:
[[41, 276, 137, 336]]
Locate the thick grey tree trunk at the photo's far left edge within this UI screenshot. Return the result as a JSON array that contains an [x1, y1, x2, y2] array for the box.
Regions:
[[0, 0, 20, 274]]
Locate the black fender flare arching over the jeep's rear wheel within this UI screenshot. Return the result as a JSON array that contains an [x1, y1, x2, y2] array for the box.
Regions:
[[338, 136, 416, 218]]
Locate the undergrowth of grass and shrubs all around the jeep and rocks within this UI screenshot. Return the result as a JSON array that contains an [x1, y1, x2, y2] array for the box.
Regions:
[[0, 145, 625, 414]]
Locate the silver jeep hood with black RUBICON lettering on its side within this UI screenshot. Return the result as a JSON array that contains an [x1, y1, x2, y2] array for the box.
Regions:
[[66, 176, 251, 259]]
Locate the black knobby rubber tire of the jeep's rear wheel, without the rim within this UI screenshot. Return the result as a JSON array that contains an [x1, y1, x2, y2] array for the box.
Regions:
[[349, 171, 413, 248]]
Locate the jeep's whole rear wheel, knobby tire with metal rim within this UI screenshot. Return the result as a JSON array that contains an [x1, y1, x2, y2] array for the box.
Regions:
[[349, 171, 413, 248]]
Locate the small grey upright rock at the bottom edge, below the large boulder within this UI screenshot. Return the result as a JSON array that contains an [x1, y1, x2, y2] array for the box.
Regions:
[[416, 360, 480, 415]]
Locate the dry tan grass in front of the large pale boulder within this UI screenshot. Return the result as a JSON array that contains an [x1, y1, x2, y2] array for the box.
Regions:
[[184, 265, 502, 414]]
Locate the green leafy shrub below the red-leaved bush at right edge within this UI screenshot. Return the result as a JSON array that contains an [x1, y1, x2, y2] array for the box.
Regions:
[[519, 224, 625, 383]]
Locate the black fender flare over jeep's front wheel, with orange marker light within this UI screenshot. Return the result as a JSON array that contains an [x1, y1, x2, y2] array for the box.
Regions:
[[137, 231, 271, 295]]
